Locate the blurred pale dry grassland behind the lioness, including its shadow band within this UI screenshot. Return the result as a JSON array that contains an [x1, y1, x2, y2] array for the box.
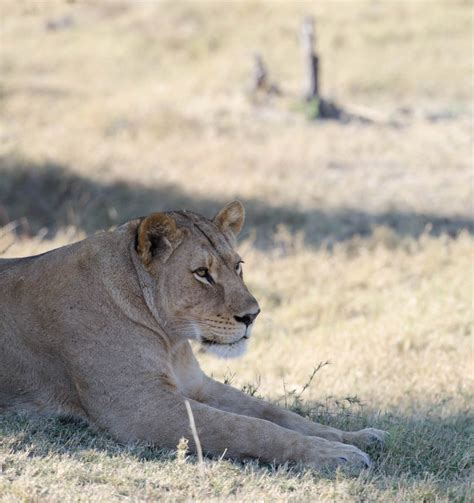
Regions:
[[0, 0, 474, 422]]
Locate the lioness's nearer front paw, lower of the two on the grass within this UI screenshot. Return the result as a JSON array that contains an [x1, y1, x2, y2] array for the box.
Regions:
[[310, 439, 372, 470]]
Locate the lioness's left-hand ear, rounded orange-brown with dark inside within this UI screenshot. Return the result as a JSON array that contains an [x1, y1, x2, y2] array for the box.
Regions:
[[136, 213, 184, 266]]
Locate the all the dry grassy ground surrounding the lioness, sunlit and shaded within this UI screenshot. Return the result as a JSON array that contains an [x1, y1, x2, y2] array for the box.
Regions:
[[0, 0, 474, 502]]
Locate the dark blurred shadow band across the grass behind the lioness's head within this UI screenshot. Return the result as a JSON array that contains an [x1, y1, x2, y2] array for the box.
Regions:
[[0, 158, 474, 249]]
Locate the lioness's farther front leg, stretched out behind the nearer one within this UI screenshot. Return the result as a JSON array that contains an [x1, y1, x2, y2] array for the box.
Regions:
[[199, 378, 386, 446]]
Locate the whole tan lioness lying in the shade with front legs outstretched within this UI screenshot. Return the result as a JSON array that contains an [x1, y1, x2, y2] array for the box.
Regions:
[[0, 201, 384, 467]]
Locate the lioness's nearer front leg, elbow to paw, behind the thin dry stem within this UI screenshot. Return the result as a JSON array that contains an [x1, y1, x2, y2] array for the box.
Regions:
[[97, 392, 370, 468]]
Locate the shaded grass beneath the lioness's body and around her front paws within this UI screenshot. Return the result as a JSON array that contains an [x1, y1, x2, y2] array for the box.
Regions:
[[0, 404, 474, 492]]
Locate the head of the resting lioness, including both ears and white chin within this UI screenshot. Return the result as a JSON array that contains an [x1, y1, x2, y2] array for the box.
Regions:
[[135, 201, 260, 358]]
